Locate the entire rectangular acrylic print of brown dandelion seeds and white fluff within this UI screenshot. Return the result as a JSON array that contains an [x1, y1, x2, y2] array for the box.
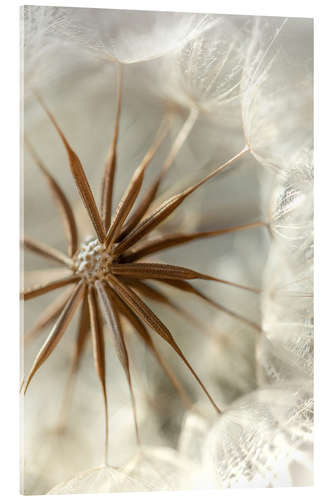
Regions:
[[21, 6, 313, 495]]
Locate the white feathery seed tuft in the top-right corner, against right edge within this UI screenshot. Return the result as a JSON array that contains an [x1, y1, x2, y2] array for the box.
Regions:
[[241, 18, 313, 170]]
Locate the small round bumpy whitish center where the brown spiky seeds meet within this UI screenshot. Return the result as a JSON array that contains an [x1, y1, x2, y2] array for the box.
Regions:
[[74, 240, 112, 282]]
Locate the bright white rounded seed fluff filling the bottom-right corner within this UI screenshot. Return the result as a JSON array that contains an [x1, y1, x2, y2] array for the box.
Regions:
[[203, 380, 313, 488]]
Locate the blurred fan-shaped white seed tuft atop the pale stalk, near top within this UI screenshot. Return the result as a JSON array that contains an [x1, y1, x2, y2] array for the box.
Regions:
[[145, 16, 247, 121]]
